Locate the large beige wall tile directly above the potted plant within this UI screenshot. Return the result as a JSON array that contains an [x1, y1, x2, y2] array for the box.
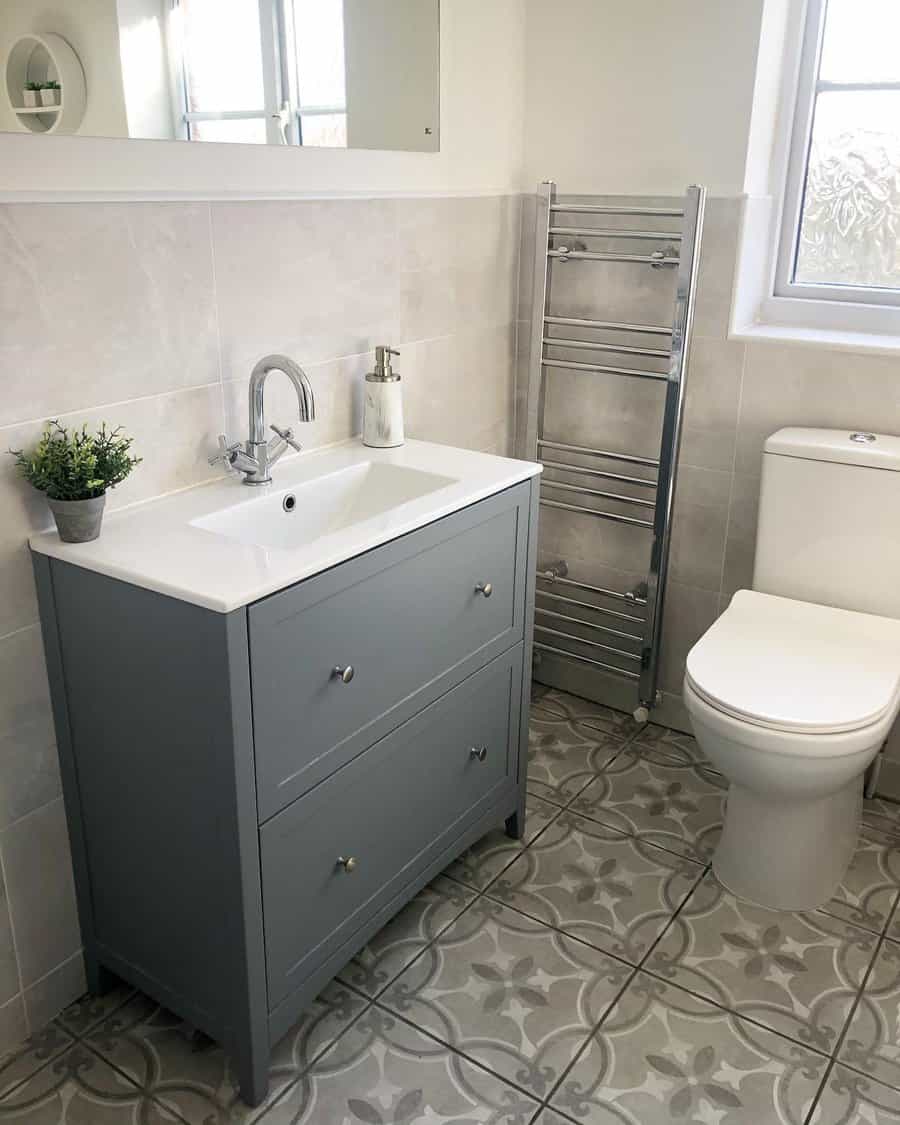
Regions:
[[0, 203, 218, 425]]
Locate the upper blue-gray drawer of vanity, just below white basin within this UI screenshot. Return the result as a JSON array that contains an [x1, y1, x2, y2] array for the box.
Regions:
[[249, 485, 530, 821]]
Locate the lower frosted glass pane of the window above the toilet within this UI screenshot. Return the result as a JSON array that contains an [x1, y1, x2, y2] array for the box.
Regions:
[[794, 90, 900, 289]]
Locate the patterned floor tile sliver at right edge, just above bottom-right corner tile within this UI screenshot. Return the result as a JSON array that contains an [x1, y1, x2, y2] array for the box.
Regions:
[[839, 942, 900, 1090]]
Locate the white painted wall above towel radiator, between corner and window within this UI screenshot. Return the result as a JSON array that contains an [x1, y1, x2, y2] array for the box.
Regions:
[[525, 0, 763, 195]]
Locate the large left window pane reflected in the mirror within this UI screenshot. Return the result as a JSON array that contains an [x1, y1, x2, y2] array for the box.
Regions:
[[181, 0, 266, 113]]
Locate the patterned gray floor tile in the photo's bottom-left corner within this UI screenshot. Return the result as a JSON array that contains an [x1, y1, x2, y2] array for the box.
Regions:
[[0, 1043, 179, 1125]]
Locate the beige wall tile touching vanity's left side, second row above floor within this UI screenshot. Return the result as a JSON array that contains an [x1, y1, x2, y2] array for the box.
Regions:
[[0, 799, 81, 989]]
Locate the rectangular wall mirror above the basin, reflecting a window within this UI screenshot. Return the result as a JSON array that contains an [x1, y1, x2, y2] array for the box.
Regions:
[[0, 0, 440, 152]]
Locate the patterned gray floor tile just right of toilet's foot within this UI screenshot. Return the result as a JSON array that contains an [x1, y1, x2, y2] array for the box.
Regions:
[[821, 825, 900, 937]]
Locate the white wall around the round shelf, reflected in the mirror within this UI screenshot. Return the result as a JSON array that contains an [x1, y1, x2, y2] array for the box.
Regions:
[[0, 0, 126, 137]]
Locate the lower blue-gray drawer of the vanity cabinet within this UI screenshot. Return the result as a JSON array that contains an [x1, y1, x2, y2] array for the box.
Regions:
[[260, 645, 523, 1009]]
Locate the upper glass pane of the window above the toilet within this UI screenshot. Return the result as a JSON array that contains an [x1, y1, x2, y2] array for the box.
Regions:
[[819, 0, 900, 82]]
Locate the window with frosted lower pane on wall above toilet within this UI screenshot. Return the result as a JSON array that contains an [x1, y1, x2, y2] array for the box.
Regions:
[[775, 0, 900, 305]]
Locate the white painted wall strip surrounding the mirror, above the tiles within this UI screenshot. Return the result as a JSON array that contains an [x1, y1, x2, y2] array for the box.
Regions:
[[0, 0, 525, 198]]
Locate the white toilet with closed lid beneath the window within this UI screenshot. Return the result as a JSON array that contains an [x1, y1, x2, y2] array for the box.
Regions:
[[684, 429, 900, 910]]
